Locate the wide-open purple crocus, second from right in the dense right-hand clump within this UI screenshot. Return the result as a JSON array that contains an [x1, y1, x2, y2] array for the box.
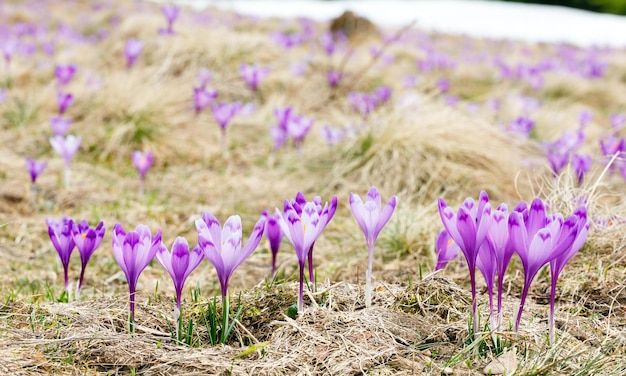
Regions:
[[509, 198, 578, 331]]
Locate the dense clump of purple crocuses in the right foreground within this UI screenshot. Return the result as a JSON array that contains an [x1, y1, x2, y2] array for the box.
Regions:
[[437, 191, 589, 342]]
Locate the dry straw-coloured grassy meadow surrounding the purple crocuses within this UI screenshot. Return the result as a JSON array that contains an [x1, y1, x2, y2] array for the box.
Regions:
[[0, 1, 626, 375]]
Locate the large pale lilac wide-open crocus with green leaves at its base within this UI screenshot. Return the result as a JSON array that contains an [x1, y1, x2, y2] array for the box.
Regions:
[[196, 212, 265, 343]]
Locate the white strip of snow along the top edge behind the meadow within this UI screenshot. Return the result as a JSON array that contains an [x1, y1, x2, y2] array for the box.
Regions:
[[168, 0, 626, 48]]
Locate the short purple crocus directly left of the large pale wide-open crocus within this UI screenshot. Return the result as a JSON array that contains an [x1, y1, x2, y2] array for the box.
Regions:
[[155, 236, 204, 341]]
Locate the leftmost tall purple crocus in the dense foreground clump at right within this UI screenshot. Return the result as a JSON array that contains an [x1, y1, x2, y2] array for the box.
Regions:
[[439, 191, 491, 333]]
